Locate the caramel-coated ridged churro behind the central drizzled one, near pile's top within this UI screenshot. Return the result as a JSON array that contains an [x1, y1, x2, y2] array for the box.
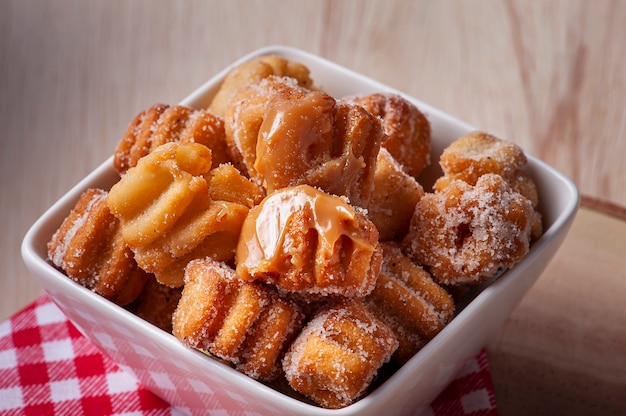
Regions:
[[254, 90, 386, 208]]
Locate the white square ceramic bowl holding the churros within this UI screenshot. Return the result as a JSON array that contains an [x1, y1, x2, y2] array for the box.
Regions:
[[22, 46, 579, 415]]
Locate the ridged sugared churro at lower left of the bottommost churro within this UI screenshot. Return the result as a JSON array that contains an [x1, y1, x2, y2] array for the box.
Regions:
[[173, 258, 302, 380]]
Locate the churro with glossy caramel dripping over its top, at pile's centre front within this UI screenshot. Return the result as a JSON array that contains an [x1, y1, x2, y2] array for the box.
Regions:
[[236, 185, 381, 296]]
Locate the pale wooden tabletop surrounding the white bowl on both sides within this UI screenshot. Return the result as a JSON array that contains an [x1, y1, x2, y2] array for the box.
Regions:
[[0, 0, 626, 415]]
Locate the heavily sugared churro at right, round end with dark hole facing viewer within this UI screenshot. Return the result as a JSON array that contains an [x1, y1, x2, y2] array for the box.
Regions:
[[405, 173, 534, 284]]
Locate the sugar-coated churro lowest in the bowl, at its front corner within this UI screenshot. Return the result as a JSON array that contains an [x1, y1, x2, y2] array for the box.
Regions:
[[283, 300, 398, 408]]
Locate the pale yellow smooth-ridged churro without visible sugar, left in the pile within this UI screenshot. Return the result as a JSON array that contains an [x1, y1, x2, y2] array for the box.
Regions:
[[107, 143, 251, 287]]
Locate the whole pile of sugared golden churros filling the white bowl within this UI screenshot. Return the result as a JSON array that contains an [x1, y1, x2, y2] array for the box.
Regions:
[[48, 56, 542, 408]]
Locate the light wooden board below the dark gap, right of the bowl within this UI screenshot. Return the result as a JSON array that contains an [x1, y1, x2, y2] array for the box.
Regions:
[[487, 208, 626, 415]]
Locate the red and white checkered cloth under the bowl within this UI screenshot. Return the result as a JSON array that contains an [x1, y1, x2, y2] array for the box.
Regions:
[[0, 296, 497, 416]]
